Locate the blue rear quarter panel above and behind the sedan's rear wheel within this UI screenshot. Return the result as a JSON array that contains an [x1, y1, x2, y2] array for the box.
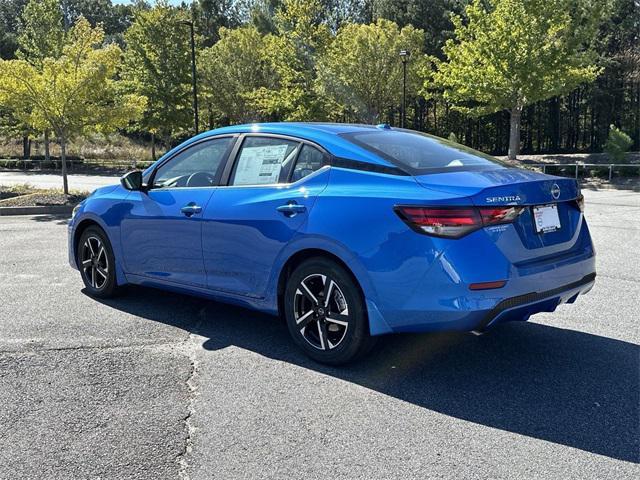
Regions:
[[278, 167, 465, 330]]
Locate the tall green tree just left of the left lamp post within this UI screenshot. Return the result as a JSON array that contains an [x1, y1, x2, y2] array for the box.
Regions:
[[123, 2, 193, 154]]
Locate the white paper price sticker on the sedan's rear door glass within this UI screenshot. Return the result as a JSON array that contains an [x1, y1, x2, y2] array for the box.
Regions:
[[233, 144, 289, 185]]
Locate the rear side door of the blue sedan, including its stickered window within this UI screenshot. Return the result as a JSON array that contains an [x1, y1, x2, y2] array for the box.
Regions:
[[203, 134, 329, 298]]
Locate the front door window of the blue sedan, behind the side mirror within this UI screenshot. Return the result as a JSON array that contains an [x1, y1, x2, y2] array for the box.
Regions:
[[153, 137, 235, 188]]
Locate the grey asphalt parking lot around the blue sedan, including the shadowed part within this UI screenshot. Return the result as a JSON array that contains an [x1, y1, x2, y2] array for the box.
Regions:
[[0, 190, 640, 479]]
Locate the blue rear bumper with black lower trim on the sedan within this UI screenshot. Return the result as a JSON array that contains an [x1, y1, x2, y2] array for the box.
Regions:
[[369, 220, 595, 335]]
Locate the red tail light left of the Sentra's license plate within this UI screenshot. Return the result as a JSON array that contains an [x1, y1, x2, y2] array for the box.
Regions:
[[395, 205, 524, 238]]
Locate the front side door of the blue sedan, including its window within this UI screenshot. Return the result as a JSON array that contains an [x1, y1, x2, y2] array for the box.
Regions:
[[121, 136, 236, 287]]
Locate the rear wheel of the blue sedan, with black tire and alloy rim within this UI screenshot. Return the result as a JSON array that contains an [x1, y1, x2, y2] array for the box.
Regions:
[[283, 257, 374, 365]]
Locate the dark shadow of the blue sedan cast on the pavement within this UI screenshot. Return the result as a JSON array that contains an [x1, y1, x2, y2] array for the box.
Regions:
[[94, 287, 640, 462]]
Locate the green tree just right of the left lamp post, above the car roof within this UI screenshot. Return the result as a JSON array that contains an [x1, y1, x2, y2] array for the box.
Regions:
[[198, 26, 275, 124]]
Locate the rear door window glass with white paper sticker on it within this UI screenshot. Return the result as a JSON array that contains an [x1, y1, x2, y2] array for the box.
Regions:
[[229, 137, 300, 185]]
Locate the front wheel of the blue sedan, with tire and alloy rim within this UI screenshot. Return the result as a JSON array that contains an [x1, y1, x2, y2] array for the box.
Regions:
[[76, 226, 118, 298]]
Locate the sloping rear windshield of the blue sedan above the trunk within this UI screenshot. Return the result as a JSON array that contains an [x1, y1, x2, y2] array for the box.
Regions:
[[342, 129, 506, 175]]
